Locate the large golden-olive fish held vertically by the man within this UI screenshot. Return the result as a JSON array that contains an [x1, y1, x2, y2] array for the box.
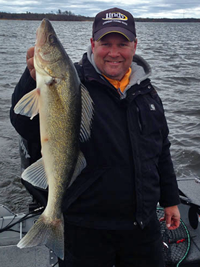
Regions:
[[14, 18, 94, 259]]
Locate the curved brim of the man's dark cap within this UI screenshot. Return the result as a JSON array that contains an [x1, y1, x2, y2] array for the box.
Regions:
[[94, 27, 136, 42]]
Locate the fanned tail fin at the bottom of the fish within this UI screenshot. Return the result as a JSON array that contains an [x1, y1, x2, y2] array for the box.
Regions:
[[17, 214, 64, 259]]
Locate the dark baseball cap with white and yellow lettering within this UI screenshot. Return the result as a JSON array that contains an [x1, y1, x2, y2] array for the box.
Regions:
[[92, 7, 136, 42]]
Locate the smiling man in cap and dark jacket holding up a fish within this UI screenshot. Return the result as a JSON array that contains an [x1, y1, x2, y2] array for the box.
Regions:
[[11, 8, 180, 267]]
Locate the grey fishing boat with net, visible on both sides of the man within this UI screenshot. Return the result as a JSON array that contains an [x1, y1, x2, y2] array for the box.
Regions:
[[0, 139, 200, 267]]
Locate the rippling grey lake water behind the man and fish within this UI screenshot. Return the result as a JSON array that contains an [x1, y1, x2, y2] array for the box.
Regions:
[[0, 21, 200, 212]]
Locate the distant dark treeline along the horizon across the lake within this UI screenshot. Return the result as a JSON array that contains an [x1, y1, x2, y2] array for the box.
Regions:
[[0, 10, 200, 22]]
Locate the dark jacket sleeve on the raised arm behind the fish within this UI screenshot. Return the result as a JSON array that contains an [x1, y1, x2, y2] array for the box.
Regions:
[[10, 68, 40, 142]]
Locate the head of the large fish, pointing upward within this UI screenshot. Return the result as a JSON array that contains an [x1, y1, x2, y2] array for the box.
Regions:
[[34, 19, 70, 79]]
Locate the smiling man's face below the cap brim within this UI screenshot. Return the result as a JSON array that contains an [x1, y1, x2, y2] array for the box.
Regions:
[[91, 33, 137, 80]]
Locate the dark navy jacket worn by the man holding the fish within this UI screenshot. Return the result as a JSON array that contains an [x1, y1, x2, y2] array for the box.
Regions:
[[11, 51, 179, 229]]
